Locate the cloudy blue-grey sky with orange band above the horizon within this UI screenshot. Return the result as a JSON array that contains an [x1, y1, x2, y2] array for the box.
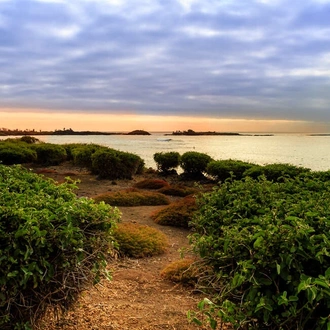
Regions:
[[0, 0, 330, 132]]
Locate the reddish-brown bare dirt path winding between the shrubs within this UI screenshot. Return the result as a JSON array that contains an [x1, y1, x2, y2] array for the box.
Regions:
[[33, 166, 213, 330]]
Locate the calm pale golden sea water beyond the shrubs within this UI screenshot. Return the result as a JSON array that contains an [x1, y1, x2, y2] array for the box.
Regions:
[[1, 133, 330, 171]]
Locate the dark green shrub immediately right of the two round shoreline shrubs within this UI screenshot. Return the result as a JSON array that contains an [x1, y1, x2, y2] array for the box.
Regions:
[[206, 159, 253, 181]]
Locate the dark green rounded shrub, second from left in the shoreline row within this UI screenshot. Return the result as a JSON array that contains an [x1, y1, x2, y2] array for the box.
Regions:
[[32, 143, 67, 166]]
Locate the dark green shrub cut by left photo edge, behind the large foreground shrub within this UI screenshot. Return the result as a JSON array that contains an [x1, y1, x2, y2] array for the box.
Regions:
[[0, 142, 37, 165]]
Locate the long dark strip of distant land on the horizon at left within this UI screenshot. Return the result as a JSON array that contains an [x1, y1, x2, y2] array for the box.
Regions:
[[0, 128, 151, 136]]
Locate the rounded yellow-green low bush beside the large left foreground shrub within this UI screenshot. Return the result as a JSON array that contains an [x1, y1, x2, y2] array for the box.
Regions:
[[114, 223, 168, 258]]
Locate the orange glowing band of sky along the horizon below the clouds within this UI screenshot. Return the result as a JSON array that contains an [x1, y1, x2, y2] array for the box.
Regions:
[[0, 109, 330, 133]]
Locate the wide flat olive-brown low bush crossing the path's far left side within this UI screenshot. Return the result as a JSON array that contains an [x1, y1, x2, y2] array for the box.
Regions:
[[94, 189, 170, 206]]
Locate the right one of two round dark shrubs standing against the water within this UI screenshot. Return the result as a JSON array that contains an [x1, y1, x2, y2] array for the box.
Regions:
[[180, 151, 212, 176]]
